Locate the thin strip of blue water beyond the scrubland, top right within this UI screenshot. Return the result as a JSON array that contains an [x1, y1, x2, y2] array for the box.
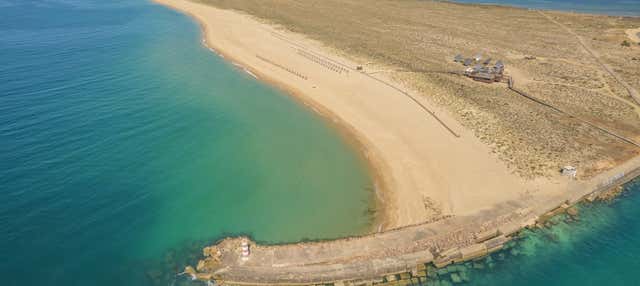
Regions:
[[453, 0, 640, 17]]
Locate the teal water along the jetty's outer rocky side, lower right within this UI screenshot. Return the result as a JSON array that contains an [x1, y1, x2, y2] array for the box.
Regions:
[[425, 179, 640, 286]]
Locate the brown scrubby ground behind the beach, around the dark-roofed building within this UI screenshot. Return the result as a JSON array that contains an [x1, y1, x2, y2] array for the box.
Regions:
[[200, 0, 640, 178]]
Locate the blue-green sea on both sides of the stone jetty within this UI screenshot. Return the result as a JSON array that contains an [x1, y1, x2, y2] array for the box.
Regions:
[[0, 0, 640, 286]]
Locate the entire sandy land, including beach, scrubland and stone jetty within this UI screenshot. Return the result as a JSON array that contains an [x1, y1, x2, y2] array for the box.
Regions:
[[146, 0, 640, 285]]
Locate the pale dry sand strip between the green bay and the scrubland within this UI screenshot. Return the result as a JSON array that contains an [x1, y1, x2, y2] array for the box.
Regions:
[[155, 0, 568, 229]]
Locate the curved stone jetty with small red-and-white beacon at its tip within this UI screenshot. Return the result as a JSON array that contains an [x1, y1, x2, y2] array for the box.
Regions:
[[187, 157, 640, 285]]
